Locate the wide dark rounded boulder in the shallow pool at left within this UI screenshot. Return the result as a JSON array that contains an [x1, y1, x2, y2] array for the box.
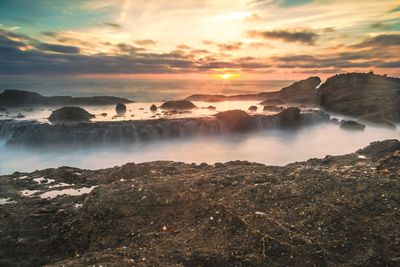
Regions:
[[48, 107, 95, 123]]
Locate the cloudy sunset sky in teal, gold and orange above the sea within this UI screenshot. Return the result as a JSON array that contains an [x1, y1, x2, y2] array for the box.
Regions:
[[0, 0, 400, 79]]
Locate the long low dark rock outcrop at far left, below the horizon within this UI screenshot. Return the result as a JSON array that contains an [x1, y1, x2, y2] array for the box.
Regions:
[[0, 90, 133, 107]]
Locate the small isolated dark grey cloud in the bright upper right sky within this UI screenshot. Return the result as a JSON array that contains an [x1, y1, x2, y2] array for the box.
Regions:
[[247, 30, 319, 45]]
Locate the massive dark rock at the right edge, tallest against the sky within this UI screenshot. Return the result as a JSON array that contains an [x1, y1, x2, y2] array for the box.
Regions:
[[318, 72, 400, 123]]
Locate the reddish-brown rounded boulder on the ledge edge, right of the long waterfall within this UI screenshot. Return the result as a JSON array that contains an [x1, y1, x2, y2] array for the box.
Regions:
[[215, 110, 252, 132]]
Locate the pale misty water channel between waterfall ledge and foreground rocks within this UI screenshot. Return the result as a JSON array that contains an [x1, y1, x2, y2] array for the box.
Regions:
[[0, 124, 400, 174]]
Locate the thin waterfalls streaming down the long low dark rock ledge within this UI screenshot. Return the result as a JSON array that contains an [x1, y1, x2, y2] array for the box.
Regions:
[[0, 112, 329, 149]]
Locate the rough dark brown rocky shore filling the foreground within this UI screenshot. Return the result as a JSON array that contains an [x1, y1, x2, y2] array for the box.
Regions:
[[0, 140, 400, 266]]
